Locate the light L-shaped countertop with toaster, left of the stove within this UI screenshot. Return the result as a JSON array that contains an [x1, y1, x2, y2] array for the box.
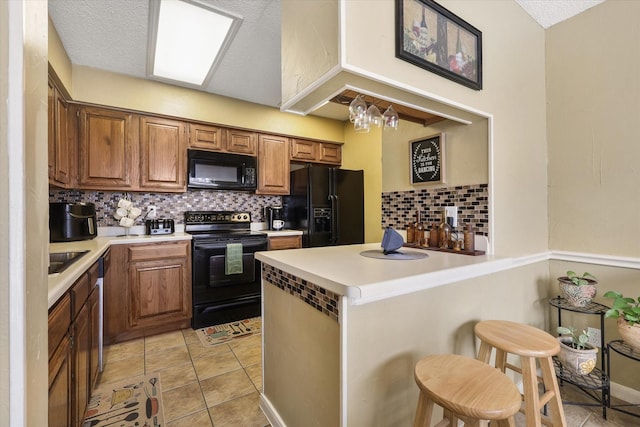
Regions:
[[48, 232, 191, 308]]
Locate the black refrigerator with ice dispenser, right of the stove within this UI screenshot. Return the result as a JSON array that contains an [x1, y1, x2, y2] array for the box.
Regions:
[[282, 166, 364, 248]]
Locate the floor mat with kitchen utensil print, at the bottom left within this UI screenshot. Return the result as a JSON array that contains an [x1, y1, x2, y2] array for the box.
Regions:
[[82, 374, 165, 427]]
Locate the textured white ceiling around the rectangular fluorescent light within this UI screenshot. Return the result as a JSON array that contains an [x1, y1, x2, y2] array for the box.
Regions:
[[49, 0, 604, 112]]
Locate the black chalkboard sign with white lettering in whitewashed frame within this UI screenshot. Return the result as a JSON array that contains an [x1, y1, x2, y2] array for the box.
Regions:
[[409, 133, 445, 184]]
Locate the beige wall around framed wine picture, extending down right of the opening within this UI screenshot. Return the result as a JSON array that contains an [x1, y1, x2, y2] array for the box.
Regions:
[[283, 0, 548, 255]]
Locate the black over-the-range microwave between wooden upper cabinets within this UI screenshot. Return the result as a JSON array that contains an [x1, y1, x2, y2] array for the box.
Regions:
[[187, 150, 258, 191]]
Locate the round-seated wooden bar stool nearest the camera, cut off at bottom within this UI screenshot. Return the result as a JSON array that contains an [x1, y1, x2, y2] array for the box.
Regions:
[[413, 354, 522, 427]]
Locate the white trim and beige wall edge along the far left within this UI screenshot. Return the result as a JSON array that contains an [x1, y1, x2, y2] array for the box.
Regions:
[[0, 1, 49, 426]]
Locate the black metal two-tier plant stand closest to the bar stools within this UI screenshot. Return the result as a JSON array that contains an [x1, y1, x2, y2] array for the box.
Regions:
[[549, 297, 611, 420]]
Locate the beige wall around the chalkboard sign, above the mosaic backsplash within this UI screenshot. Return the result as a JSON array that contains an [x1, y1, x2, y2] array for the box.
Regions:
[[382, 120, 489, 192]]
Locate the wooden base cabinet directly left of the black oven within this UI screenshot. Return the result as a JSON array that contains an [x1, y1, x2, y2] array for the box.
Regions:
[[105, 240, 192, 344]]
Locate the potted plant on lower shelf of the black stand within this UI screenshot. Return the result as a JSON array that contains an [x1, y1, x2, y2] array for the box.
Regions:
[[558, 326, 598, 375]]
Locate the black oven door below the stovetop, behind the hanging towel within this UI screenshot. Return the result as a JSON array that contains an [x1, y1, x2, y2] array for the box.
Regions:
[[192, 236, 267, 304]]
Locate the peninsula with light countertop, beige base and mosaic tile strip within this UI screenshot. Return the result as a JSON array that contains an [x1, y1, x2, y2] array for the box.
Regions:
[[256, 243, 548, 427]]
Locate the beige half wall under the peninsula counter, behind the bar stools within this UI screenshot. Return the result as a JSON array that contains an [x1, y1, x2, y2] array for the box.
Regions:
[[343, 262, 548, 427]]
